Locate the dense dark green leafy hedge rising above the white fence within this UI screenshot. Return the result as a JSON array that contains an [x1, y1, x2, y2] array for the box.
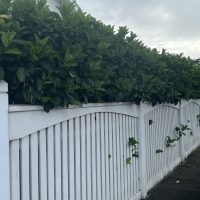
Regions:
[[0, 0, 200, 110]]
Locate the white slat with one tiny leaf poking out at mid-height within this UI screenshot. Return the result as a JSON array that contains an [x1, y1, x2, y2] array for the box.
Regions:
[[108, 113, 114, 200]]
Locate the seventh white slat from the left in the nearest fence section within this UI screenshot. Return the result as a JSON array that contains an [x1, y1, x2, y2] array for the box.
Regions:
[[62, 121, 69, 200]]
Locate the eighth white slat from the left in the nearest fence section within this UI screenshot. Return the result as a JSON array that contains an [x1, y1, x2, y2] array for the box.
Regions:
[[68, 119, 75, 200]]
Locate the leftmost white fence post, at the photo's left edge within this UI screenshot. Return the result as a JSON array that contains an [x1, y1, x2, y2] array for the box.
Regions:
[[0, 81, 10, 200]]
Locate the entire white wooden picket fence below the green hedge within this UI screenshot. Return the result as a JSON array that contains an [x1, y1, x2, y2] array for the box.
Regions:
[[0, 82, 200, 200]]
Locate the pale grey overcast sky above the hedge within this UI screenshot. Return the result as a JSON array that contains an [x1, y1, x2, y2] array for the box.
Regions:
[[74, 0, 200, 58]]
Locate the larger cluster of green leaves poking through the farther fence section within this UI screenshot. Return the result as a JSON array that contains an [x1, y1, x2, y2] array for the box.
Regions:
[[166, 124, 193, 147]]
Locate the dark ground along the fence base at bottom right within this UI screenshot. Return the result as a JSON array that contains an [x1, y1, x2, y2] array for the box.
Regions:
[[146, 148, 200, 200]]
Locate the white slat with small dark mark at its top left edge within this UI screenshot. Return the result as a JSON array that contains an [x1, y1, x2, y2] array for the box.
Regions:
[[96, 113, 101, 200]]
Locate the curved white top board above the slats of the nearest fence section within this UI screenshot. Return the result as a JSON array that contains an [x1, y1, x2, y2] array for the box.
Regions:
[[9, 104, 138, 140]]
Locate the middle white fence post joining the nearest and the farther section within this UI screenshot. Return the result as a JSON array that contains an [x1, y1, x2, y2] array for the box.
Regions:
[[138, 103, 147, 198]]
